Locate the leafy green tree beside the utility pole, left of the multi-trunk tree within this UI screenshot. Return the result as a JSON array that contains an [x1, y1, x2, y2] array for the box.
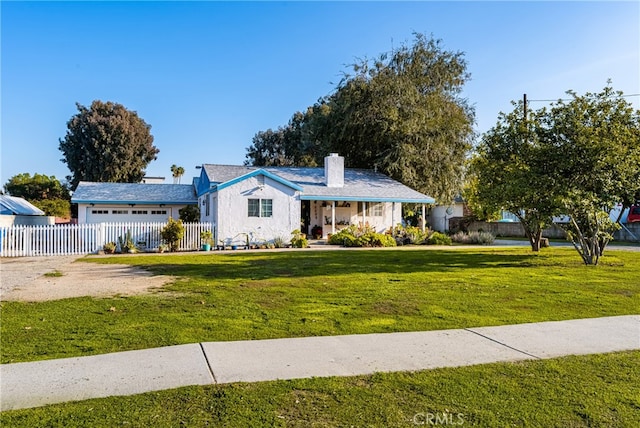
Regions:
[[465, 102, 560, 251]]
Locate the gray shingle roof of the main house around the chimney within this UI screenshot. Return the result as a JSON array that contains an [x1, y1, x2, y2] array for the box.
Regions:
[[203, 164, 435, 203]]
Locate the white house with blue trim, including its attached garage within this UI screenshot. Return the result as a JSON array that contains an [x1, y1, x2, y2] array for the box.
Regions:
[[71, 154, 435, 245]]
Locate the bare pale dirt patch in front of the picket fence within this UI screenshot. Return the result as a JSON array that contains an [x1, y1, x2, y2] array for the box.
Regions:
[[0, 256, 175, 302]]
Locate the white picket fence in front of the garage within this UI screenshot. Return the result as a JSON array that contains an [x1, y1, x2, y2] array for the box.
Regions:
[[0, 223, 212, 257]]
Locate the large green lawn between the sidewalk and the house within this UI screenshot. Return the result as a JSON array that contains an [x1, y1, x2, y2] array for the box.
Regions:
[[0, 248, 640, 363]]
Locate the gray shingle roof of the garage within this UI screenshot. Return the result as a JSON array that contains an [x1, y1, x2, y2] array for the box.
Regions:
[[71, 181, 198, 204]]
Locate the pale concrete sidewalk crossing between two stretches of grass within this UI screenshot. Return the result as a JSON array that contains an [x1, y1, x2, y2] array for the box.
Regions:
[[0, 315, 640, 410]]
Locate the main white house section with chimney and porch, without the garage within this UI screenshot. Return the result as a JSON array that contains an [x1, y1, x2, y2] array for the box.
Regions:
[[195, 154, 435, 243]]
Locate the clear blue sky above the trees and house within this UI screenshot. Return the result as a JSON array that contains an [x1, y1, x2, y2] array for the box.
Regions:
[[0, 1, 640, 185]]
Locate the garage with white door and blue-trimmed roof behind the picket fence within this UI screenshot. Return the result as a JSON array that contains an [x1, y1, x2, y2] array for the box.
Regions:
[[71, 181, 197, 224]]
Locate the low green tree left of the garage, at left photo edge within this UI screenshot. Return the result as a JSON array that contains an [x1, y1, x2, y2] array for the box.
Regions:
[[4, 173, 71, 218]]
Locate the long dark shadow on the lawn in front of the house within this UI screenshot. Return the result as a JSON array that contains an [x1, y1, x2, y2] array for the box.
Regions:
[[143, 250, 536, 280]]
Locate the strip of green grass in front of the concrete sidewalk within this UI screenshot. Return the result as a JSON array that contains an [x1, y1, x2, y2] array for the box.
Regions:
[[0, 352, 640, 428]]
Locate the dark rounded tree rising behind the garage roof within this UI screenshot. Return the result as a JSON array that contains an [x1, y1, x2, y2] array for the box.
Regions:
[[59, 100, 159, 189]]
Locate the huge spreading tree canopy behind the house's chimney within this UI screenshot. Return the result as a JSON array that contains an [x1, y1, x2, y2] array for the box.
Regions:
[[246, 34, 474, 202]]
